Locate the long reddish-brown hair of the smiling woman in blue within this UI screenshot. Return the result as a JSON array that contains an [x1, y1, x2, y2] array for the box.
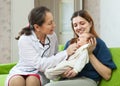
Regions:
[[71, 10, 98, 37]]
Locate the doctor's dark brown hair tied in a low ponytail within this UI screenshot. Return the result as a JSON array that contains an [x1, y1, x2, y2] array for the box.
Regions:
[[15, 6, 50, 40]]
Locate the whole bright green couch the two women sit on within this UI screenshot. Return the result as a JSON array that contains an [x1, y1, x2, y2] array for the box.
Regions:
[[0, 45, 120, 86]]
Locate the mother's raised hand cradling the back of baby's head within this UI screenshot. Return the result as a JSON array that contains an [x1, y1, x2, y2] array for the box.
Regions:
[[88, 37, 97, 54]]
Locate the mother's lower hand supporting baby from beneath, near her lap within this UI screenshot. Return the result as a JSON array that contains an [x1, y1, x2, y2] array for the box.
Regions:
[[62, 67, 78, 78]]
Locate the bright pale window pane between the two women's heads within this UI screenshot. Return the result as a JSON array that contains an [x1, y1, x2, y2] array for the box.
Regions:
[[58, 0, 74, 44]]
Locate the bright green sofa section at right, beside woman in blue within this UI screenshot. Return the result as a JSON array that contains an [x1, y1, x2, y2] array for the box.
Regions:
[[99, 48, 120, 86]]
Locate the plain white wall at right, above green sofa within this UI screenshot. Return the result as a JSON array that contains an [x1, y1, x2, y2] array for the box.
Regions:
[[100, 0, 120, 47]]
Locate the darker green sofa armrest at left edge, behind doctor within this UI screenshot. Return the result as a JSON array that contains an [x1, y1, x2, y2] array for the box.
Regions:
[[0, 63, 16, 75]]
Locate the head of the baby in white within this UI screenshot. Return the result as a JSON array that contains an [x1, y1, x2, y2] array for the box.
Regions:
[[77, 33, 94, 46]]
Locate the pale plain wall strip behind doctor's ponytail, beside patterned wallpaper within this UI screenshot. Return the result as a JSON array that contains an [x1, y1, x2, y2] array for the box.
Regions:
[[11, 0, 34, 62]]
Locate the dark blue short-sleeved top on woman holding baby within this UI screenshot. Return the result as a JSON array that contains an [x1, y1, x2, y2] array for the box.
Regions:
[[64, 38, 116, 81]]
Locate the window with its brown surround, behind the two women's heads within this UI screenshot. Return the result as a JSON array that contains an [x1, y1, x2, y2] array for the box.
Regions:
[[35, 0, 82, 44]]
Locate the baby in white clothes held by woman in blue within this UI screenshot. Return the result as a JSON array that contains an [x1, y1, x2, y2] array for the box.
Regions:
[[45, 33, 94, 80]]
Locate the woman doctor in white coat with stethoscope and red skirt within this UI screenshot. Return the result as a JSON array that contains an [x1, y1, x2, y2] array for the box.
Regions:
[[6, 7, 77, 86]]
